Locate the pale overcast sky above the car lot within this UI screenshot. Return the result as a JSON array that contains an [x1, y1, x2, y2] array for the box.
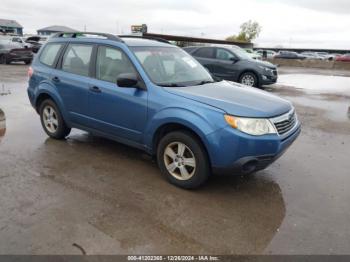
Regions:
[[0, 0, 350, 49]]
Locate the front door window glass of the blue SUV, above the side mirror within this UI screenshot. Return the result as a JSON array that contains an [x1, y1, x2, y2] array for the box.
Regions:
[[96, 46, 136, 83]]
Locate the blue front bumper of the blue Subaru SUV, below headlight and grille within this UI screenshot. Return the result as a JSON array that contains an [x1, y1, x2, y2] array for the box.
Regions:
[[208, 123, 301, 175]]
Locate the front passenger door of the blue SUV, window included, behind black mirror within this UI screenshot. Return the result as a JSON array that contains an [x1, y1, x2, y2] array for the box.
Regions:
[[89, 45, 148, 144]]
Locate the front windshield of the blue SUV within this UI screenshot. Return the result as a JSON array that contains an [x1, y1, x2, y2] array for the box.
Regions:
[[131, 46, 214, 87]]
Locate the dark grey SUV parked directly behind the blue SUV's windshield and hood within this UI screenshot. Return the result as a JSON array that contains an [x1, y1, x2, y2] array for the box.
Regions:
[[184, 46, 277, 87]]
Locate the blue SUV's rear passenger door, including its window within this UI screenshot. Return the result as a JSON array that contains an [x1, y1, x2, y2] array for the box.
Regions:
[[51, 43, 94, 126]]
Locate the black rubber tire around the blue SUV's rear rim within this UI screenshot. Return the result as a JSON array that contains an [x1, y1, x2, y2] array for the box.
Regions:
[[39, 99, 71, 140]]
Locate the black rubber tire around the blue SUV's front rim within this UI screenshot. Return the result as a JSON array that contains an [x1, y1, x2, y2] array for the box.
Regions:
[[157, 131, 210, 189]]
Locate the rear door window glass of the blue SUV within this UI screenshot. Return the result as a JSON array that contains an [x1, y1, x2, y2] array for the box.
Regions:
[[62, 44, 93, 76]]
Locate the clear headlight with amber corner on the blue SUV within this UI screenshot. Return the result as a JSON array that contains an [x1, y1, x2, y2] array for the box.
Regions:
[[225, 115, 277, 136]]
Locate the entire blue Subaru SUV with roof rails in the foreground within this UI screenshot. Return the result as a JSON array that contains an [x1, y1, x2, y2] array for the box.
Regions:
[[28, 33, 300, 188]]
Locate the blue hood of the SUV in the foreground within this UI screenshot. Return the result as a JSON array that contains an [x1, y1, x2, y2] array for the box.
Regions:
[[164, 81, 292, 118]]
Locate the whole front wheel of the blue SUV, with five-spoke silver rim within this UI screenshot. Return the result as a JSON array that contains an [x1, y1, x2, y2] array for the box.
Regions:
[[157, 131, 210, 189]]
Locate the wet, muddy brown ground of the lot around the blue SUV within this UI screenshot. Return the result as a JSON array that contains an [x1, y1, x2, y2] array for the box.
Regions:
[[0, 65, 350, 254]]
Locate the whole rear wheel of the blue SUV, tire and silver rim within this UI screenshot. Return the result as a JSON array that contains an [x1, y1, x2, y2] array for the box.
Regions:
[[39, 99, 71, 139]]
